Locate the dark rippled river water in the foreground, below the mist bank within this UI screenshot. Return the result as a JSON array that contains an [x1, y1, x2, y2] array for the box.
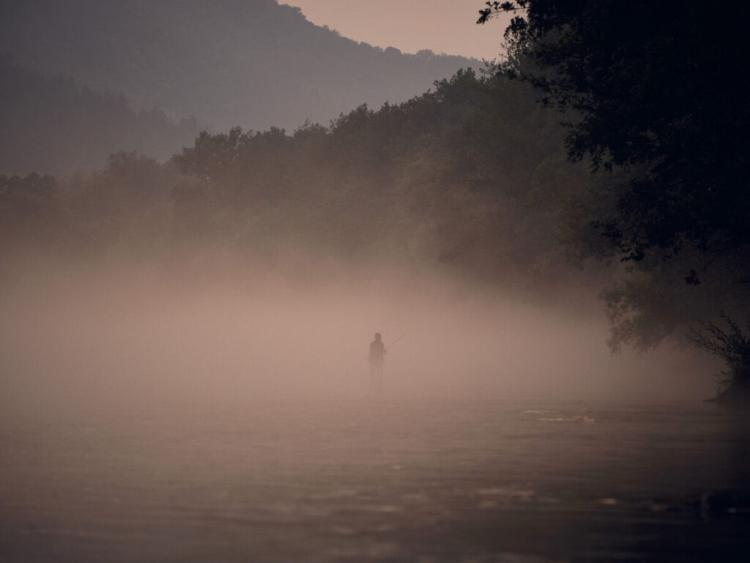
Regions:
[[0, 400, 750, 562]]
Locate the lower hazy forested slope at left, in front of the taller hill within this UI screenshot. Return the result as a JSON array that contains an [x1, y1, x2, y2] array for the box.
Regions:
[[0, 57, 198, 174]]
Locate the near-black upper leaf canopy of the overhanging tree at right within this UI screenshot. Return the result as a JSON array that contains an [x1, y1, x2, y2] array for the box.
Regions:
[[480, 0, 750, 266]]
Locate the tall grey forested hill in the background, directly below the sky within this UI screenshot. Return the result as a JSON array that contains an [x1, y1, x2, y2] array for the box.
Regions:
[[0, 0, 478, 129]]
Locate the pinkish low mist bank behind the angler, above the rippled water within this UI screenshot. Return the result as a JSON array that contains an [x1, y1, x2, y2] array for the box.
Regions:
[[0, 250, 711, 418]]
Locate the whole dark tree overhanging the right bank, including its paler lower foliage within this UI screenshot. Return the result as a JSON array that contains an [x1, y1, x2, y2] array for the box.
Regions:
[[479, 0, 750, 398]]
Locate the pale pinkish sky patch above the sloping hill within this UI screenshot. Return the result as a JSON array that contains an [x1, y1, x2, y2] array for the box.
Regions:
[[280, 0, 505, 59]]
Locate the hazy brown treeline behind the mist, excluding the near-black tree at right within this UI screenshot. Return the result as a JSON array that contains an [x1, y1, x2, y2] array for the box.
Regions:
[[0, 70, 586, 298]]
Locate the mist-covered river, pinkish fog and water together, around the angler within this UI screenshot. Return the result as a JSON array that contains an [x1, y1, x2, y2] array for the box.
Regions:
[[0, 267, 750, 561]]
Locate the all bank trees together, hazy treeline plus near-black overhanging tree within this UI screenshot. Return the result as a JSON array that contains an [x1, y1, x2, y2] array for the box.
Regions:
[[0, 1, 750, 405]]
